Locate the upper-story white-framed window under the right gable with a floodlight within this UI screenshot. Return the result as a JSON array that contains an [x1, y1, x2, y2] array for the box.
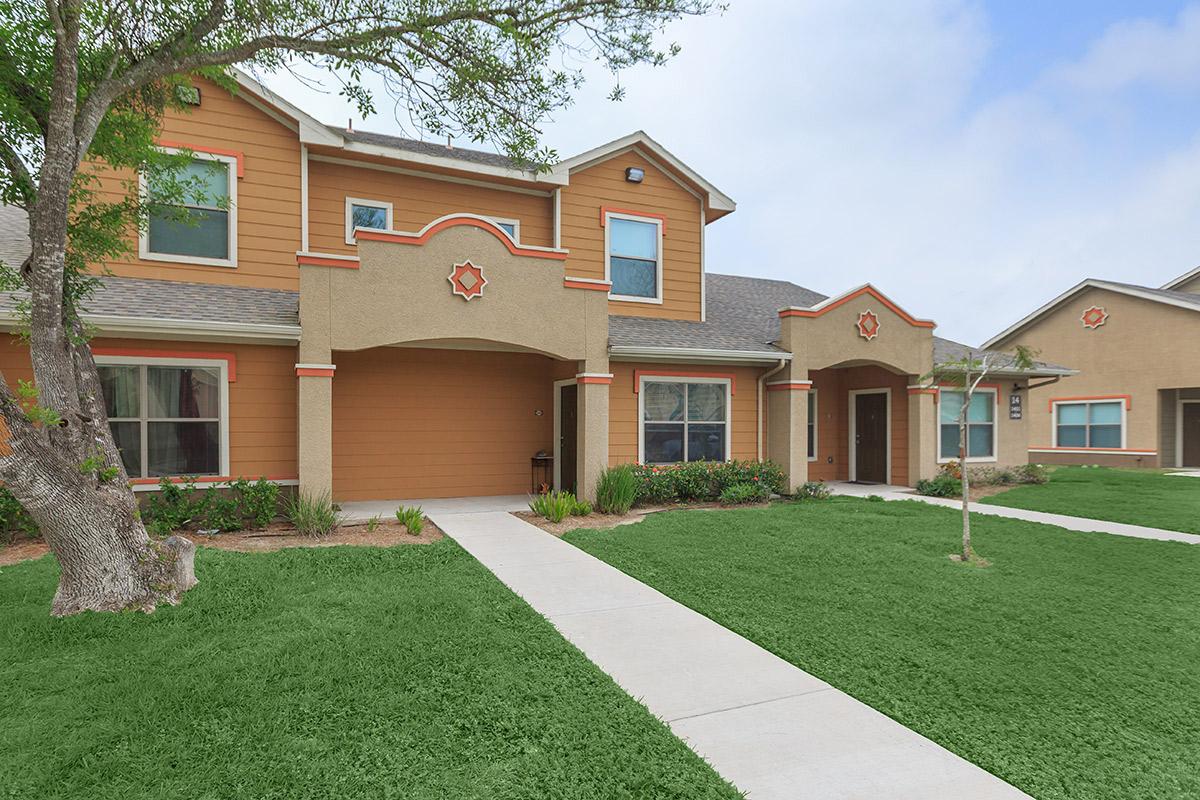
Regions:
[[605, 211, 662, 303]]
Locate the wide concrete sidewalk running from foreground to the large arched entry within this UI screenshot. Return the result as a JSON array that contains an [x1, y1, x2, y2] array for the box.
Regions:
[[430, 511, 1028, 800]]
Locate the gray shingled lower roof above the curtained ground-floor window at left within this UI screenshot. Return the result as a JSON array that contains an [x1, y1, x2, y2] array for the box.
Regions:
[[0, 276, 300, 325]]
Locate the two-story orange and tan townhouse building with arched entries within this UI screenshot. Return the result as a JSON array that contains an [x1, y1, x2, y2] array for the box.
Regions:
[[0, 77, 1070, 500]]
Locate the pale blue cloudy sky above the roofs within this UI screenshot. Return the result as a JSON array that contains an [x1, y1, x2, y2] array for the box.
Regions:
[[268, 0, 1200, 344]]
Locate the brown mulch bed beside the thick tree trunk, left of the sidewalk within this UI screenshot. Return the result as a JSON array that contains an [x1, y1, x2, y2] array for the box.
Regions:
[[0, 519, 445, 566]]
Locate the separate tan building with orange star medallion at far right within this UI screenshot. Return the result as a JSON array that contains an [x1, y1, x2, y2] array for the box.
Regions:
[[984, 269, 1200, 467]]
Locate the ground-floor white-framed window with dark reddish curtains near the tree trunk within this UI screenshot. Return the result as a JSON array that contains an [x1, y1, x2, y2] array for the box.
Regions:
[[96, 356, 229, 479]]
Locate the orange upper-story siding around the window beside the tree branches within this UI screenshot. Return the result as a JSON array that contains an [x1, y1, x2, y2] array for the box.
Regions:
[[86, 80, 300, 289]]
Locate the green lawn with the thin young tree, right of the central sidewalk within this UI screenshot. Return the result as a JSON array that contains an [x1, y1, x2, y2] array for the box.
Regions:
[[566, 501, 1200, 800]]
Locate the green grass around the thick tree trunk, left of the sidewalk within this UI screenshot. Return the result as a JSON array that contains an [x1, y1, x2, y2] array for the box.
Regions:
[[0, 540, 739, 800]]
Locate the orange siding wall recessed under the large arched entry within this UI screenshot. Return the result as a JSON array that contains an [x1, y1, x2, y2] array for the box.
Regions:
[[334, 348, 575, 500]]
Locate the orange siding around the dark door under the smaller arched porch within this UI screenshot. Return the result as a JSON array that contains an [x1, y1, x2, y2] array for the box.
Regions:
[[809, 367, 908, 486]]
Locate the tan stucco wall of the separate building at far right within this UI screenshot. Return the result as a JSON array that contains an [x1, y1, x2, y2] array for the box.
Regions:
[[997, 288, 1200, 467]]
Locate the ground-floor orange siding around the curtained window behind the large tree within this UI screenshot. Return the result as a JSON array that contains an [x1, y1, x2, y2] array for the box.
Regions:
[[0, 333, 298, 479]]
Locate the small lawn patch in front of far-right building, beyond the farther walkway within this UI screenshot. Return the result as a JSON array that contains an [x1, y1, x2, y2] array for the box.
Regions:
[[982, 467, 1200, 534]]
